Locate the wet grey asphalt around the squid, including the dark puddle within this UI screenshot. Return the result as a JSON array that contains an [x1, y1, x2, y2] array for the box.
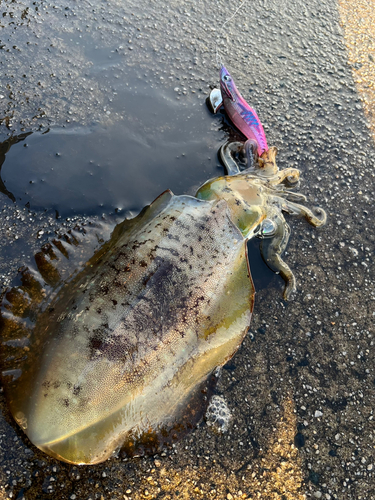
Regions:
[[0, 0, 375, 500]]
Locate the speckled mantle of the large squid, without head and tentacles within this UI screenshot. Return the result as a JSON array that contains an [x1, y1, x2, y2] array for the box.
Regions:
[[3, 191, 254, 463]]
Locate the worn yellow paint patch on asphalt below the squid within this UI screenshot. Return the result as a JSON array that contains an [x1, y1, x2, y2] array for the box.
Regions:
[[154, 396, 306, 500]]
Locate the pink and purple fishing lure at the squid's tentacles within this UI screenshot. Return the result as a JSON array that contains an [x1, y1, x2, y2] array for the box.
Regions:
[[220, 66, 268, 156]]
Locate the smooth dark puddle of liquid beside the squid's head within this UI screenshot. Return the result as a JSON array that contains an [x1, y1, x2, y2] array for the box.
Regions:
[[1, 82, 224, 217]]
